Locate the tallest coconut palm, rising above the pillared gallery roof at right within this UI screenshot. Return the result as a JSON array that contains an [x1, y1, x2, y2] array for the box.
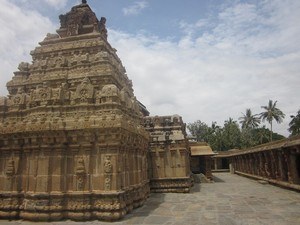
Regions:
[[260, 100, 285, 141]]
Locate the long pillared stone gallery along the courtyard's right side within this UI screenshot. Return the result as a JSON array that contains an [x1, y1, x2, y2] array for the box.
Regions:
[[227, 136, 300, 191]]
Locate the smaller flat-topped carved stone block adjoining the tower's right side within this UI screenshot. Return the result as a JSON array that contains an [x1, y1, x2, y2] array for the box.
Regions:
[[144, 115, 191, 192]]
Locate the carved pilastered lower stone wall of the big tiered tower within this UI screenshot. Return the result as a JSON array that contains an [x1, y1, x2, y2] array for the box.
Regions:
[[0, 128, 149, 221]]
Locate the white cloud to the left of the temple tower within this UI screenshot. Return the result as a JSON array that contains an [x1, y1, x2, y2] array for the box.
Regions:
[[0, 0, 55, 95]]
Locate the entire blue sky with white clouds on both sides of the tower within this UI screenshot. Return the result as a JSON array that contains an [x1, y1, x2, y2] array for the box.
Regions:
[[0, 0, 300, 136]]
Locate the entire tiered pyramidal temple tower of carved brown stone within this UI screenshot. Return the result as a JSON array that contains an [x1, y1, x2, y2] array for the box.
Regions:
[[0, 1, 149, 221]]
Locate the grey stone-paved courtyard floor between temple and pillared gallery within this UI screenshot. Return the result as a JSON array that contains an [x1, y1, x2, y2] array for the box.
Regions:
[[0, 173, 300, 225]]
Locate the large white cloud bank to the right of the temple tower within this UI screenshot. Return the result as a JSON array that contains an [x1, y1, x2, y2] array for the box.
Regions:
[[109, 1, 300, 135]]
